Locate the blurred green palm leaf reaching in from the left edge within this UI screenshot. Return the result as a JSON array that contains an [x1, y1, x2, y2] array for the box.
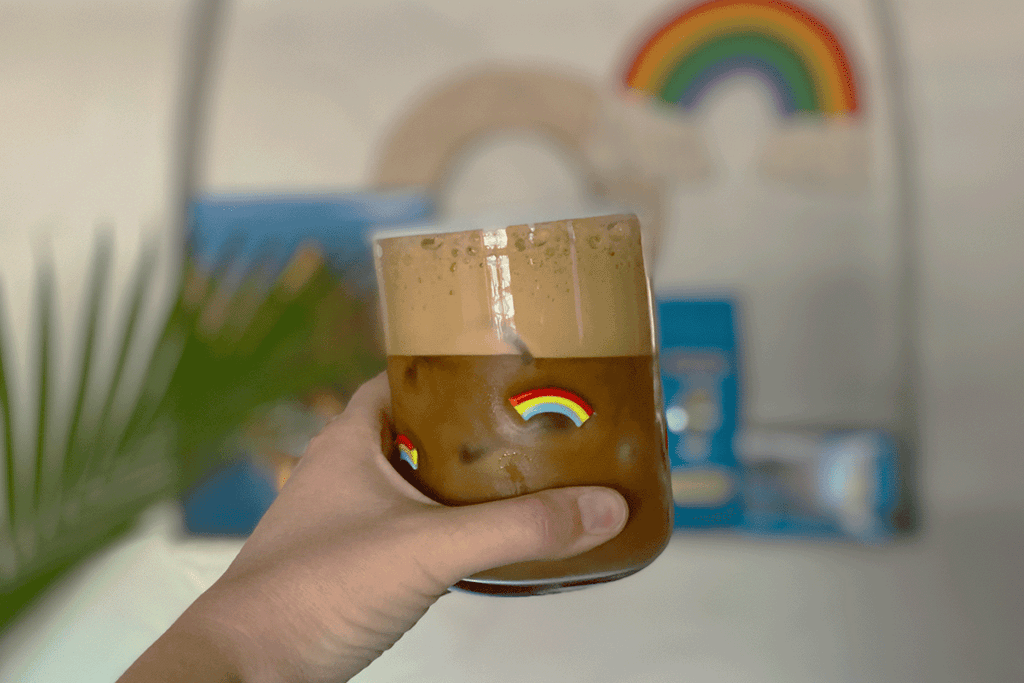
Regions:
[[0, 223, 383, 626]]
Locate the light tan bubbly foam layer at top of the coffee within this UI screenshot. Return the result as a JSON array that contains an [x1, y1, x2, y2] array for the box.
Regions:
[[374, 214, 653, 358]]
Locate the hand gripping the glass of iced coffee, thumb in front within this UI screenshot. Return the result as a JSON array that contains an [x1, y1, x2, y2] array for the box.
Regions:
[[121, 374, 628, 682]]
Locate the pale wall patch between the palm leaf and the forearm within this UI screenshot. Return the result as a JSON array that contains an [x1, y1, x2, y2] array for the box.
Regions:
[[0, 504, 242, 683]]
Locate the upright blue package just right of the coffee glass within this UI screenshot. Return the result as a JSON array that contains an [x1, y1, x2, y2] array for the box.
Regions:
[[657, 298, 742, 528]]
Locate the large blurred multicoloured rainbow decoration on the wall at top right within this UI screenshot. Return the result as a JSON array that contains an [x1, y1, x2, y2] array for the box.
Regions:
[[625, 0, 860, 115]]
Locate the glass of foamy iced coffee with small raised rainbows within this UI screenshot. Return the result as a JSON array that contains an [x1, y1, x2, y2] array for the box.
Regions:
[[374, 215, 673, 595]]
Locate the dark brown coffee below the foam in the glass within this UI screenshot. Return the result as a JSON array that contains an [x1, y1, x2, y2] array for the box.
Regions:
[[388, 354, 673, 595]]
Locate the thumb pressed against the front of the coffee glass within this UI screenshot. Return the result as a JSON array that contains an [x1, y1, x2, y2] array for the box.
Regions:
[[419, 486, 629, 585]]
